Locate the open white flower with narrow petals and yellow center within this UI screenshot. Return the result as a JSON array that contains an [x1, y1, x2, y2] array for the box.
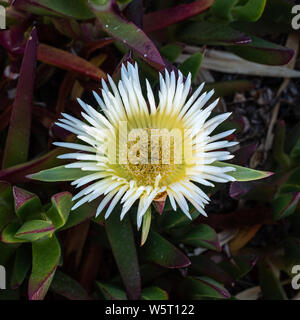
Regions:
[[54, 63, 237, 228]]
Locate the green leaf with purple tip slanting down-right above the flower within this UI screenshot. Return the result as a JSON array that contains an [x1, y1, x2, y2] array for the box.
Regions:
[[89, 0, 165, 69]]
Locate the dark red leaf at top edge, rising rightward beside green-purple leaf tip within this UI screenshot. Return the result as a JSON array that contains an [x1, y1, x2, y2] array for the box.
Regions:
[[143, 0, 214, 32]]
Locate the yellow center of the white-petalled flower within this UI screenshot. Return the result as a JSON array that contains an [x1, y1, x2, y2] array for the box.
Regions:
[[105, 113, 195, 187]]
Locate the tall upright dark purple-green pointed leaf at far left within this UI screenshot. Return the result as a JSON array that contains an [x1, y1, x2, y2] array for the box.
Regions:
[[2, 28, 38, 168]]
